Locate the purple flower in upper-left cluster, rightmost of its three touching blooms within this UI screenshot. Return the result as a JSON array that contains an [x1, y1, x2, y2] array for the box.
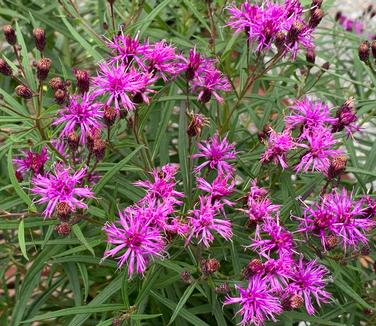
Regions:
[[143, 40, 179, 81]]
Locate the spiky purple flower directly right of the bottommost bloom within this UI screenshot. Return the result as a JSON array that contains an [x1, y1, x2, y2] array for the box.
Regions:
[[286, 258, 331, 315]]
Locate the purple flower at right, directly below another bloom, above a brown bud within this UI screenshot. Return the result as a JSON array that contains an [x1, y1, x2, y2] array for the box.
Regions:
[[295, 127, 342, 172]]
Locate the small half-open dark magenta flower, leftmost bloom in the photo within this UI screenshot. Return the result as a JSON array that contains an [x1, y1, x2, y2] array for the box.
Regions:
[[13, 147, 48, 175]]
